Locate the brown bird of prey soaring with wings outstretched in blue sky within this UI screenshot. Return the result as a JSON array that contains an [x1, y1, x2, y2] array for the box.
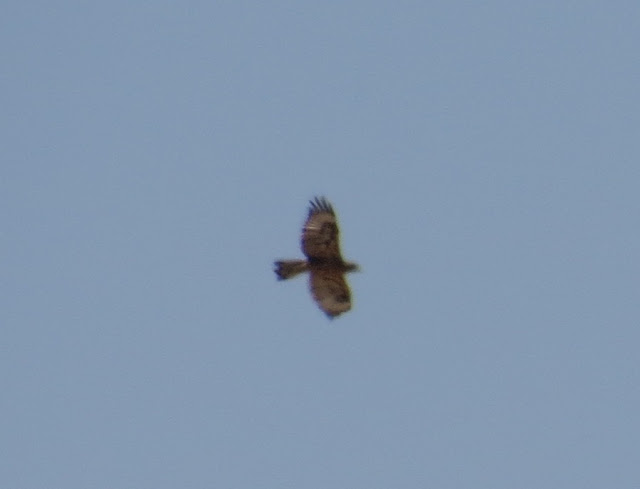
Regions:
[[274, 197, 358, 319]]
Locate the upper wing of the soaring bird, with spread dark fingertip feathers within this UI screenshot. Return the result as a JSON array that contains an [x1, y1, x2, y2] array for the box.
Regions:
[[302, 197, 342, 261]]
